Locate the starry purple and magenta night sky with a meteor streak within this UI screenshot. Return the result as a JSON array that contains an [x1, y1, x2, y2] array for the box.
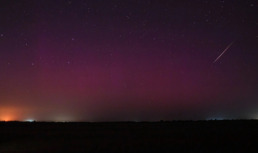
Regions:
[[0, 0, 258, 121]]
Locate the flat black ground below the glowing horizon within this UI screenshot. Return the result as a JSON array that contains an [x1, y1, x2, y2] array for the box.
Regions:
[[0, 121, 258, 153]]
